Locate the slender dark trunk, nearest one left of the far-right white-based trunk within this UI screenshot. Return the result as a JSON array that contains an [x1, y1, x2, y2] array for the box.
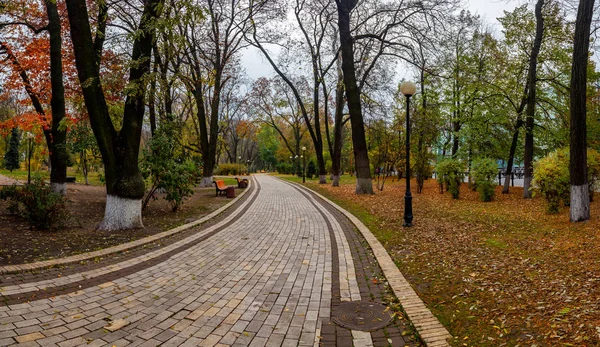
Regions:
[[523, 0, 544, 199]]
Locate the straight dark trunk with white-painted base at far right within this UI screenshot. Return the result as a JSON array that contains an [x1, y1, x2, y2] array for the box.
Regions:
[[569, 0, 594, 222]]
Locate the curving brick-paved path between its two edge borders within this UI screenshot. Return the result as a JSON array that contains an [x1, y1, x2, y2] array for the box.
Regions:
[[0, 175, 418, 346]]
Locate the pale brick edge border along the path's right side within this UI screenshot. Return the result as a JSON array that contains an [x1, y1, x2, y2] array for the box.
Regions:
[[292, 182, 452, 347]]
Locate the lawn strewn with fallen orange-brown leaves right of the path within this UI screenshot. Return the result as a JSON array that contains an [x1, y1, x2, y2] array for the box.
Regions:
[[288, 176, 600, 347]]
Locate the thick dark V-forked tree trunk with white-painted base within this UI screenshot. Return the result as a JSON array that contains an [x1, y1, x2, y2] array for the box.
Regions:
[[66, 0, 163, 230]]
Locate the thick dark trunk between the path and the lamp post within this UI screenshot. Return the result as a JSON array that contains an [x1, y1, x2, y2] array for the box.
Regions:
[[336, 0, 373, 194]]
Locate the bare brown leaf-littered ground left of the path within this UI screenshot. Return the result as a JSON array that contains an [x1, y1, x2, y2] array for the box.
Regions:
[[0, 184, 232, 266]]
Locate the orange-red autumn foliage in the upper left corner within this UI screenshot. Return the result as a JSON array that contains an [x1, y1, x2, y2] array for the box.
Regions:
[[0, 0, 79, 131]]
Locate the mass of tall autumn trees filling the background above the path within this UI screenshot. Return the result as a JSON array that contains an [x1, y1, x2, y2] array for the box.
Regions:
[[0, 0, 597, 229]]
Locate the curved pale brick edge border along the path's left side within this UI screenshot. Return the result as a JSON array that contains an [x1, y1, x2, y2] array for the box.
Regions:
[[0, 181, 250, 275]]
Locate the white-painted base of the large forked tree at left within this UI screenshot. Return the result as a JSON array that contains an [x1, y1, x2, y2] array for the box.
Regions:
[[98, 195, 144, 230]]
